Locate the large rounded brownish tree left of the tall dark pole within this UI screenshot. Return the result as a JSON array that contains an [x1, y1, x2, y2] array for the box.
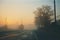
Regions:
[[34, 5, 53, 28]]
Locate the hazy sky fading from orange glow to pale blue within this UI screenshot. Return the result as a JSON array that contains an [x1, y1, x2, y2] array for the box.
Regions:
[[0, 0, 60, 24]]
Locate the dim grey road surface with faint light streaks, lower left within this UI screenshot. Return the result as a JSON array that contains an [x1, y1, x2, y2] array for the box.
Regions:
[[0, 31, 38, 40]]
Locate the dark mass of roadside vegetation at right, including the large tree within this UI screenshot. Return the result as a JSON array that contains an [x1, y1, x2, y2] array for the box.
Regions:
[[34, 5, 60, 40]]
